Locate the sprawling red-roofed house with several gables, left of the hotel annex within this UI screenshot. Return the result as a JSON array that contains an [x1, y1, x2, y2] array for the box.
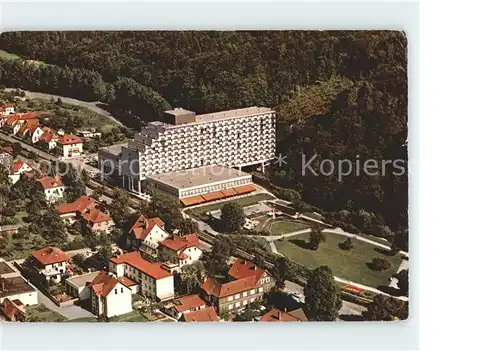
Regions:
[[56, 195, 115, 233]]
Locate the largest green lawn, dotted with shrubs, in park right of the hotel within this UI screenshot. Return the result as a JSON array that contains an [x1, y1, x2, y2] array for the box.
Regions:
[[274, 233, 401, 288]]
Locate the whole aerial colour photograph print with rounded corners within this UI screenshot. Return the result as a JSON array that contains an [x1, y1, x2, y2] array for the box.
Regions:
[[0, 30, 410, 323]]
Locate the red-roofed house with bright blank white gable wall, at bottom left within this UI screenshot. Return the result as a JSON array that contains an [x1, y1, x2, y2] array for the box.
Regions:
[[89, 271, 132, 318]]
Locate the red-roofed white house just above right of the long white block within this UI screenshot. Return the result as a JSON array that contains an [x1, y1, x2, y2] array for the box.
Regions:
[[159, 234, 203, 273]]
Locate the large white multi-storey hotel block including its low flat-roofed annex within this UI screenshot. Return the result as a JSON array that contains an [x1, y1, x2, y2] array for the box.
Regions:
[[99, 107, 276, 206]]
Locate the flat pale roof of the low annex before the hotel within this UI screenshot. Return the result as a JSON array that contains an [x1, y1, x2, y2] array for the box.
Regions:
[[148, 165, 250, 189]]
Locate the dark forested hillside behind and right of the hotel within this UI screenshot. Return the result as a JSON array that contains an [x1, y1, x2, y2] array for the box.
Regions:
[[0, 31, 408, 239]]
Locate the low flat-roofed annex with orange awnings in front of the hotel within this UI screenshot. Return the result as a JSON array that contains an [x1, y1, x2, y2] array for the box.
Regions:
[[147, 165, 255, 206]]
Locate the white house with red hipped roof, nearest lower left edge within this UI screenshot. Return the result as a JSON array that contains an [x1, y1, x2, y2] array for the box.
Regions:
[[31, 247, 69, 282]]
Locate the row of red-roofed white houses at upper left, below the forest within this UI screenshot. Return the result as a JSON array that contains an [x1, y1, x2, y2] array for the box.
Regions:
[[0, 104, 83, 158]]
